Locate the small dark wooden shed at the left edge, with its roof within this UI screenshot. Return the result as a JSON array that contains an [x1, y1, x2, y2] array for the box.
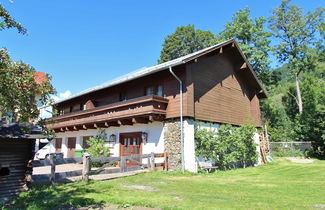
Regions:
[[0, 123, 42, 202]]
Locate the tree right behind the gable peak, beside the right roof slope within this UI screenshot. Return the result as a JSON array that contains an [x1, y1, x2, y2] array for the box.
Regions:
[[218, 7, 271, 82]]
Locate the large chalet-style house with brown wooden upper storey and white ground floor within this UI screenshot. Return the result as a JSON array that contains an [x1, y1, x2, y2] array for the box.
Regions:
[[48, 40, 266, 171]]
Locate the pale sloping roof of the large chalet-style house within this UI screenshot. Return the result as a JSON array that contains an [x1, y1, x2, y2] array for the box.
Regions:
[[55, 39, 266, 104]]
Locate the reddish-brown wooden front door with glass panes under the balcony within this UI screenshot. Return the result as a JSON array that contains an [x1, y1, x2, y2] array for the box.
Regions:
[[120, 132, 142, 166]]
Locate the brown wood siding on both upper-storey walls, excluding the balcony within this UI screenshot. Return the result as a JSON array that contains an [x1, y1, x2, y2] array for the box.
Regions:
[[54, 45, 261, 126]]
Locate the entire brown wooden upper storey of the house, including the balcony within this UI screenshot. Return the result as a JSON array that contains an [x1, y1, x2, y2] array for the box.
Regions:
[[49, 41, 266, 132]]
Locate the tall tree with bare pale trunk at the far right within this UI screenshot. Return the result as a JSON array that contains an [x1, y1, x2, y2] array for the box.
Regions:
[[269, 0, 324, 113]]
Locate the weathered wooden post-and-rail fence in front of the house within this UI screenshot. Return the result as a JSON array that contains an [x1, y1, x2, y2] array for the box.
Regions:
[[32, 153, 168, 184]]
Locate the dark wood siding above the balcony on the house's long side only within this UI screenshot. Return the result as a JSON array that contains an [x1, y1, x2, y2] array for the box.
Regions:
[[58, 65, 193, 118]]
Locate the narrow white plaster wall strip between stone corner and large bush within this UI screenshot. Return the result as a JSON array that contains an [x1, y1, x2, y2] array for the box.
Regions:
[[183, 120, 197, 173]]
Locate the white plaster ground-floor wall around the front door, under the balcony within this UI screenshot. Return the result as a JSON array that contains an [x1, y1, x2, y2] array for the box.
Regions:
[[56, 122, 164, 159]]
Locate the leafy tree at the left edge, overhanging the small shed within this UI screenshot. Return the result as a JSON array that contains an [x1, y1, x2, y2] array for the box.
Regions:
[[0, 5, 54, 124]]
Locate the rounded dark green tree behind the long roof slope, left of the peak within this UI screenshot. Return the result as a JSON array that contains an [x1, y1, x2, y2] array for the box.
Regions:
[[158, 25, 216, 63]]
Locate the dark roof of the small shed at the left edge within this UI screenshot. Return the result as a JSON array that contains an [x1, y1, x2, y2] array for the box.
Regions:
[[0, 123, 44, 139]]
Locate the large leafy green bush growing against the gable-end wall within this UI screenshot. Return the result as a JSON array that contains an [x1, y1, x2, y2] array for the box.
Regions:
[[195, 125, 257, 169]]
